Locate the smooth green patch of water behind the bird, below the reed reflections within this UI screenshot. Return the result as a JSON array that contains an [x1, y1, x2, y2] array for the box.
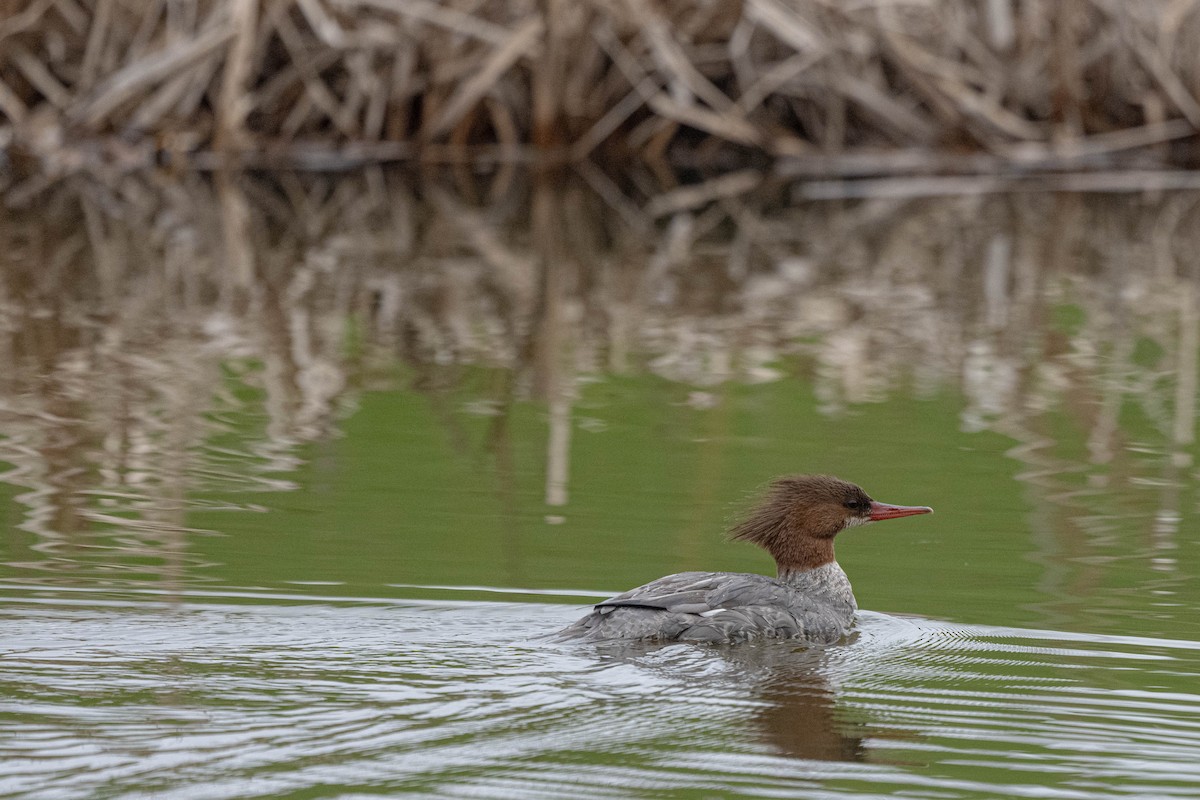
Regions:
[[190, 379, 1032, 624]]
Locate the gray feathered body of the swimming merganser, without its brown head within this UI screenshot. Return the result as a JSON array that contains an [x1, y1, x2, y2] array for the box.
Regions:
[[559, 561, 858, 644]]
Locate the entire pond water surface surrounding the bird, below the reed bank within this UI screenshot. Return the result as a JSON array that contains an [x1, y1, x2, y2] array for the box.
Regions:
[[0, 172, 1200, 799]]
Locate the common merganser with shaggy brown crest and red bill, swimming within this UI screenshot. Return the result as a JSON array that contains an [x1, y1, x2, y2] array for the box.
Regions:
[[558, 475, 934, 644]]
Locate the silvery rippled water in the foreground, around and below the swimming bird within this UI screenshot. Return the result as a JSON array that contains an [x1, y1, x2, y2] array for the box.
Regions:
[[0, 599, 1200, 800]]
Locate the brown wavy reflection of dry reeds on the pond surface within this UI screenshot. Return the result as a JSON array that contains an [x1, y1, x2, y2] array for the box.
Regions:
[[0, 169, 1200, 596]]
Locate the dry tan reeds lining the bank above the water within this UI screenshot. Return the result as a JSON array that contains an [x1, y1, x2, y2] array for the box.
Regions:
[[0, 0, 1200, 174]]
